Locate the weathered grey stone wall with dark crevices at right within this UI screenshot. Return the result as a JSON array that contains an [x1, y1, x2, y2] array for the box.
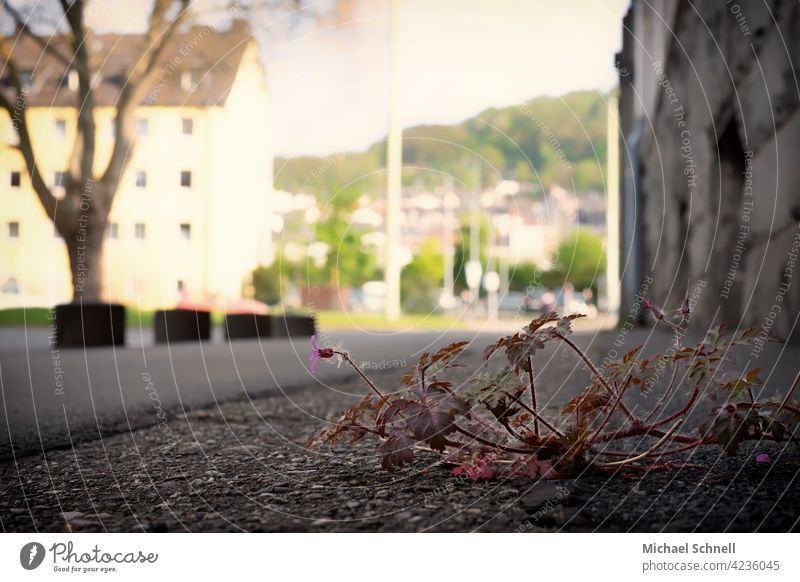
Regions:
[[619, 0, 800, 337]]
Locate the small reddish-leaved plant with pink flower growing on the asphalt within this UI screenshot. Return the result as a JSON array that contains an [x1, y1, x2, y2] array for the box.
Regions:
[[308, 299, 800, 479]]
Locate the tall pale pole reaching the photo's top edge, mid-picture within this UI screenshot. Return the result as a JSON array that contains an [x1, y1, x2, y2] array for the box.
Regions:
[[384, 0, 403, 321]]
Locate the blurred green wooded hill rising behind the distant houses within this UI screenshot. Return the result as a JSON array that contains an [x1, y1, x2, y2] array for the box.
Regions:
[[275, 91, 606, 194]]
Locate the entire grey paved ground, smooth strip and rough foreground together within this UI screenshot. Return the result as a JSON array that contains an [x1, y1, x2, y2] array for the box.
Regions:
[[0, 329, 800, 531]]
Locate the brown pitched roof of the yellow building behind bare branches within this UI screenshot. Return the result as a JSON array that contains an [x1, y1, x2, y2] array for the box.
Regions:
[[0, 20, 252, 107]]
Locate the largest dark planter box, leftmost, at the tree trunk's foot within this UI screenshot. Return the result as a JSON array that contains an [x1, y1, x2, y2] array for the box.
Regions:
[[55, 303, 125, 348]]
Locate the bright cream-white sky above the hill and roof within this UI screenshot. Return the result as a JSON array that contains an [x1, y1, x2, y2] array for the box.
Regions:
[[89, 0, 630, 157]]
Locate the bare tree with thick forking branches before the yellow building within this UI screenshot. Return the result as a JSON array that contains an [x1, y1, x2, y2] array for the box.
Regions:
[[0, 0, 191, 301]]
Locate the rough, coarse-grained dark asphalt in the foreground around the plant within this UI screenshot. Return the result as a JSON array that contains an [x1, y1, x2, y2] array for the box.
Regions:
[[0, 328, 800, 532]]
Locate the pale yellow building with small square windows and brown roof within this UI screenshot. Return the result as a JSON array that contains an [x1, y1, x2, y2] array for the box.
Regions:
[[0, 21, 272, 309]]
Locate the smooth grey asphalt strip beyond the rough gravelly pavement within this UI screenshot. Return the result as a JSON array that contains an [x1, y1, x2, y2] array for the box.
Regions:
[[0, 332, 491, 460]]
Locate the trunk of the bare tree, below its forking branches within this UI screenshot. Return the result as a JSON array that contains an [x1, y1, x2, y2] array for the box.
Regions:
[[57, 183, 111, 303]]
